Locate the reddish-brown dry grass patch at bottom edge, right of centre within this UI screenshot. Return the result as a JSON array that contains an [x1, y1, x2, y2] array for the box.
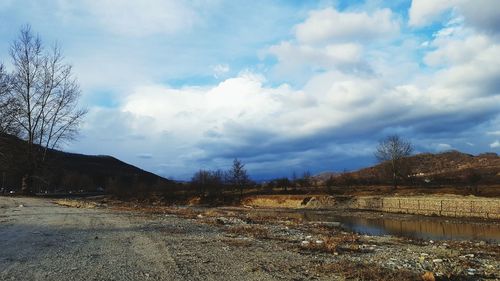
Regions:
[[318, 260, 421, 281]]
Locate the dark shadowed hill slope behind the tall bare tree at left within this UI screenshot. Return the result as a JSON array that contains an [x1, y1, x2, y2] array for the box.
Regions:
[[0, 134, 171, 191]]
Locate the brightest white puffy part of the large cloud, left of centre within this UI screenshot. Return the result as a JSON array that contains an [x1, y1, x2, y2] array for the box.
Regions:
[[123, 73, 300, 137]]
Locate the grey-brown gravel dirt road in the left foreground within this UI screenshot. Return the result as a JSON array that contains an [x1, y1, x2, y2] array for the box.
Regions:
[[0, 197, 333, 280]]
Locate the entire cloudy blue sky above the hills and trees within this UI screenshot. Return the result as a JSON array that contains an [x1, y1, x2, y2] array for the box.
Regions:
[[0, 0, 500, 180]]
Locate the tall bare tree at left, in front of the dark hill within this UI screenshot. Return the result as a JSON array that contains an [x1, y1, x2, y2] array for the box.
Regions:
[[8, 25, 86, 192]]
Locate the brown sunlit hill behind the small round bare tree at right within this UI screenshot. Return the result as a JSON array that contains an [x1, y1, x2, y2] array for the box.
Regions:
[[315, 151, 500, 184]]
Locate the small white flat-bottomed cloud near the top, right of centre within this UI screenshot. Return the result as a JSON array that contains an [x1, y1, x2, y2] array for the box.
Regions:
[[295, 8, 399, 44]]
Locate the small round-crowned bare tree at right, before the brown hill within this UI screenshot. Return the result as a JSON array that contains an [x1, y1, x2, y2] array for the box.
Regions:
[[375, 135, 413, 189]]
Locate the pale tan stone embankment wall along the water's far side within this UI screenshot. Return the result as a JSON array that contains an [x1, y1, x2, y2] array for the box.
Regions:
[[350, 196, 500, 219]]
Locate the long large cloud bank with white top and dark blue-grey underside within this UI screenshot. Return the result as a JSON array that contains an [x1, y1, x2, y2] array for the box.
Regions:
[[106, 49, 500, 175]]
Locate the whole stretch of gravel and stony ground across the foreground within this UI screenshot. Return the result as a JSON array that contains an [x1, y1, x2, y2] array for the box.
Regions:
[[0, 197, 500, 280]]
